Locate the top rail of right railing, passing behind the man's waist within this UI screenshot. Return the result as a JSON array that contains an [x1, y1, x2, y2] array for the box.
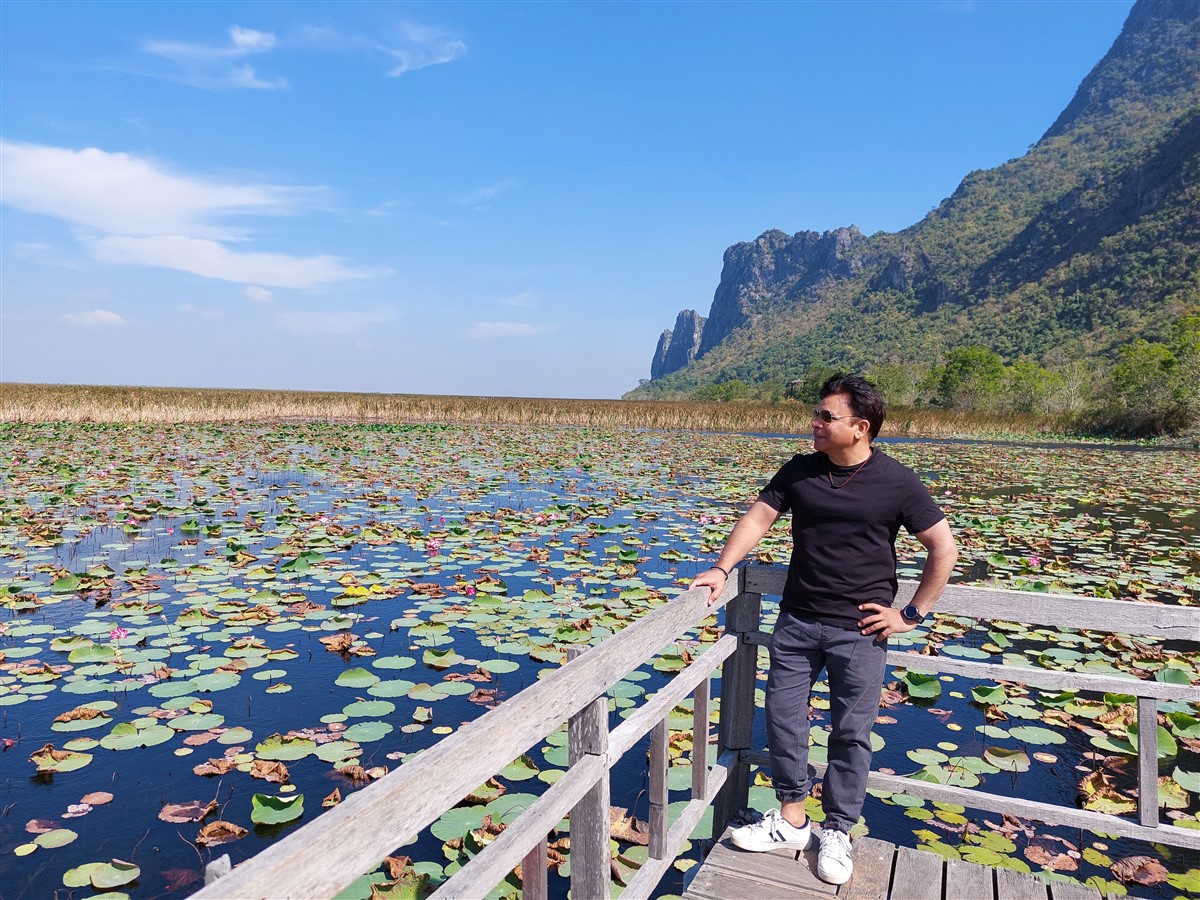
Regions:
[[743, 565, 1200, 641]]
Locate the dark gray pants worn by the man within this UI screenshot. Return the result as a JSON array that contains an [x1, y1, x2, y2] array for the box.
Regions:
[[767, 611, 888, 833]]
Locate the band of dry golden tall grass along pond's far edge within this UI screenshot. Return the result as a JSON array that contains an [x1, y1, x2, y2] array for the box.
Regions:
[[0, 383, 1062, 437]]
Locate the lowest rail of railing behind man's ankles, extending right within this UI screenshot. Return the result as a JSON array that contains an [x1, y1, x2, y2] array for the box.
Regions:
[[742, 750, 1200, 850]]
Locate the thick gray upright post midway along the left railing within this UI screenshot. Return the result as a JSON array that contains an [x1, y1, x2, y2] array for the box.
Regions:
[[566, 657, 612, 900]]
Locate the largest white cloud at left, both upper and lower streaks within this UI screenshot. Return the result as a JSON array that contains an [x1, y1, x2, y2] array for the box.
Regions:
[[0, 142, 373, 288]]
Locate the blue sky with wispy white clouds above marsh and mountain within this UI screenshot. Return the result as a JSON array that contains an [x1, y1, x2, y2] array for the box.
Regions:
[[0, 0, 1132, 397]]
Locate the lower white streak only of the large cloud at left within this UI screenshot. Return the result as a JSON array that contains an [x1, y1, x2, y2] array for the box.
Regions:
[[92, 234, 368, 288]]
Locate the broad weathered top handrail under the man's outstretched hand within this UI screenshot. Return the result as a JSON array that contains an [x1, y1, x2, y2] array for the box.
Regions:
[[196, 580, 738, 900]]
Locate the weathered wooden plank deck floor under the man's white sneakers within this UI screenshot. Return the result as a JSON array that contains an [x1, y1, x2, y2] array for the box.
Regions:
[[683, 830, 1103, 900]]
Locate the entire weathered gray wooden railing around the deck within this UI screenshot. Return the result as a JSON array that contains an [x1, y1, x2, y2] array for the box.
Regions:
[[194, 565, 1200, 900]]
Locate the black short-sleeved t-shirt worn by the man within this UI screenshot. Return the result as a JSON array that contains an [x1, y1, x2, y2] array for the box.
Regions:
[[758, 448, 946, 629]]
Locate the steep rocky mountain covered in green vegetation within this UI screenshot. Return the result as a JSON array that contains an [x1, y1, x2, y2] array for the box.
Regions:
[[626, 0, 1200, 398]]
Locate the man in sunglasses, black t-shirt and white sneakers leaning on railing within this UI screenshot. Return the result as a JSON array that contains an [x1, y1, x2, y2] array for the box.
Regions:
[[691, 376, 958, 884]]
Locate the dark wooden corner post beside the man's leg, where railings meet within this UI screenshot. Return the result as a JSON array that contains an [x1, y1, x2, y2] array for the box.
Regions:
[[713, 568, 762, 840]]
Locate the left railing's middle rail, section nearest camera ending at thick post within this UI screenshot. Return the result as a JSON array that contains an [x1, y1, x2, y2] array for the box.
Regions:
[[431, 756, 610, 900]]
